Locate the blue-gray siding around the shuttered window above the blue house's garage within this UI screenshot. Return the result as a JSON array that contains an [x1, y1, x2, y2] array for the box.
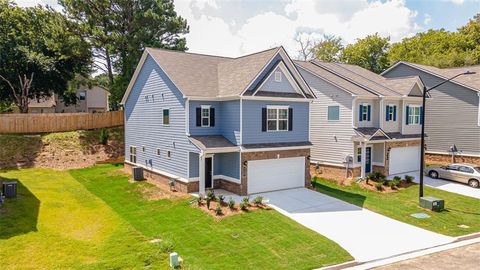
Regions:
[[242, 100, 309, 144]]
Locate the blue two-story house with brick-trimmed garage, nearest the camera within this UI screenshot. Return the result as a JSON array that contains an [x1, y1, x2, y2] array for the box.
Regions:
[[122, 47, 314, 195]]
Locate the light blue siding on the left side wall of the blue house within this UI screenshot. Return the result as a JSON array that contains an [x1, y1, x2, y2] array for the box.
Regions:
[[124, 56, 198, 178]]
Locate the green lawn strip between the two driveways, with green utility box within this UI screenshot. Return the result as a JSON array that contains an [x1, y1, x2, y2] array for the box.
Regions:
[[316, 178, 480, 236]]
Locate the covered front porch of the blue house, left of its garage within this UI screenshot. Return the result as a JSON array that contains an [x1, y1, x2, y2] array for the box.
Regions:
[[188, 135, 241, 194]]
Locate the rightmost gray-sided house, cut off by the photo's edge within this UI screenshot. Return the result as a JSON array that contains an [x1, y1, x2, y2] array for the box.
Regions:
[[382, 62, 480, 163]]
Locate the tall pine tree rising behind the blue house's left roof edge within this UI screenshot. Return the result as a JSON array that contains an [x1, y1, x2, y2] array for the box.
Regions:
[[59, 0, 188, 108]]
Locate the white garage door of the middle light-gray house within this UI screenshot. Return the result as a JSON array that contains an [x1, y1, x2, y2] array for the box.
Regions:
[[389, 146, 420, 174]]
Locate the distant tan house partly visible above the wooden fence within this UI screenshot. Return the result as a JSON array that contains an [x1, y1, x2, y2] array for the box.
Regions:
[[28, 86, 110, 113]]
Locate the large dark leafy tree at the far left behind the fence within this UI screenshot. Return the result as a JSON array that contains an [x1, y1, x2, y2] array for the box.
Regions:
[[0, 0, 91, 113]]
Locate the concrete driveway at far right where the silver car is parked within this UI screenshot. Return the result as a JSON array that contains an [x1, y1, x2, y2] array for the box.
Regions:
[[388, 171, 480, 199]]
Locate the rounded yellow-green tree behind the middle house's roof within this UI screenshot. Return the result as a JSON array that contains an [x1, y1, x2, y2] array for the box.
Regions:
[[340, 34, 390, 73]]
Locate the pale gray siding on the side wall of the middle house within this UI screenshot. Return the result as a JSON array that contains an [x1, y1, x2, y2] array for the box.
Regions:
[[299, 67, 355, 165]]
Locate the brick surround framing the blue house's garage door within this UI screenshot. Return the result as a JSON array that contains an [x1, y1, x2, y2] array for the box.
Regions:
[[237, 149, 311, 195]]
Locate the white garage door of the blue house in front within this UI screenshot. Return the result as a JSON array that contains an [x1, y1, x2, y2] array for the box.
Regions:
[[248, 157, 305, 194]]
